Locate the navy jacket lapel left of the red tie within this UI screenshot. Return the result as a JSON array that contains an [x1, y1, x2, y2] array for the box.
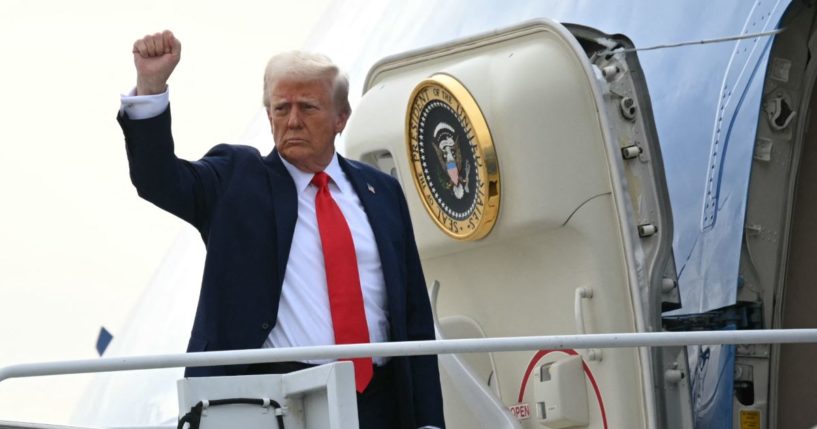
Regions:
[[264, 149, 298, 286]]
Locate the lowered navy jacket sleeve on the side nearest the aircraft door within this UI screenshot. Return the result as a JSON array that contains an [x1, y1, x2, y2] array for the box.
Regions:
[[397, 179, 445, 428]]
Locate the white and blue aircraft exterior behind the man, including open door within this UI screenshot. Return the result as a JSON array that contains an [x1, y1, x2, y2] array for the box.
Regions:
[[9, 0, 817, 429]]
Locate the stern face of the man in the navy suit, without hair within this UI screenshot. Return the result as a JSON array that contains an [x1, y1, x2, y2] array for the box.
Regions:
[[267, 78, 349, 172]]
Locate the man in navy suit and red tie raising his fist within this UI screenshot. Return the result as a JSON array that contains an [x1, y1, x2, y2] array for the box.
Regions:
[[118, 31, 444, 429]]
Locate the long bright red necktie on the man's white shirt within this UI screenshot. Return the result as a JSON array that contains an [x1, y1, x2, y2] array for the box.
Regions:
[[312, 172, 374, 392]]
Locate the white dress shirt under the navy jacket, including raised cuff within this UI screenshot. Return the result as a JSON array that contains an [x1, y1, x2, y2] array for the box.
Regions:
[[120, 89, 389, 365]]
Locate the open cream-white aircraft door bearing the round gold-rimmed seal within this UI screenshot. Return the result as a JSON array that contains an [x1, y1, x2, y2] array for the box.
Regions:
[[346, 20, 691, 428]]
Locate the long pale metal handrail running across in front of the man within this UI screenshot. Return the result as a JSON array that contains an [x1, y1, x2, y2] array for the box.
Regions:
[[0, 329, 817, 382]]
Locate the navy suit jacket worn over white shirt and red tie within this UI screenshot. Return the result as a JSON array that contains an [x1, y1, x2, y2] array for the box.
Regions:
[[117, 107, 443, 428]]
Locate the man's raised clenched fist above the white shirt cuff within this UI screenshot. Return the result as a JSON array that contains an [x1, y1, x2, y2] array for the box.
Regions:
[[133, 30, 182, 95]]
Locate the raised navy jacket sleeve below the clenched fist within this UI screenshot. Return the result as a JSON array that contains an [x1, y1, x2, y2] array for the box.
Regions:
[[117, 107, 233, 236]]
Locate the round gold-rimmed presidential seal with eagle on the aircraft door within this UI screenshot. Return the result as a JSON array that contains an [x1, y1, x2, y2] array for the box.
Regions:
[[406, 74, 499, 240]]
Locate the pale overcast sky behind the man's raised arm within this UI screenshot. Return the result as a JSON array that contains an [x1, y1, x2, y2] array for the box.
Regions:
[[0, 0, 329, 423]]
